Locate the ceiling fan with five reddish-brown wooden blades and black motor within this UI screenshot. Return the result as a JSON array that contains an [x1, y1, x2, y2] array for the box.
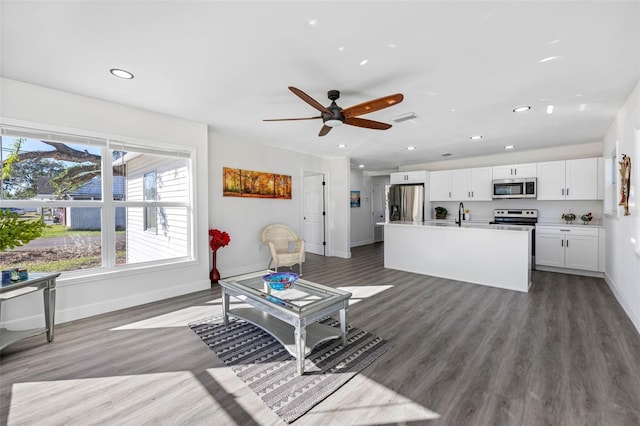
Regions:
[[263, 86, 404, 136]]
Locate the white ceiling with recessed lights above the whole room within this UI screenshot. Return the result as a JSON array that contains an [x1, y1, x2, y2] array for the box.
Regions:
[[0, 0, 640, 171]]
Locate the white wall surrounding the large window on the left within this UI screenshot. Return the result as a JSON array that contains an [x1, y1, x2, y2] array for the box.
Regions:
[[0, 79, 210, 328]]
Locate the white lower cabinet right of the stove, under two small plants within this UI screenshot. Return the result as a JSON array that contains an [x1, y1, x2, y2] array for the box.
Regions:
[[536, 225, 599, 271]]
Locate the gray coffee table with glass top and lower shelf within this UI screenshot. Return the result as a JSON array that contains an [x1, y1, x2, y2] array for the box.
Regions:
[[218, 271, 351, 375]]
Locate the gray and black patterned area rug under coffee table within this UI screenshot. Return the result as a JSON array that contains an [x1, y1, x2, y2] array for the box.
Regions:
[[189, 317, 392, 423]]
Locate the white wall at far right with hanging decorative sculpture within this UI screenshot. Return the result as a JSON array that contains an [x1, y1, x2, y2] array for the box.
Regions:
[[602, 82, 640, 331]]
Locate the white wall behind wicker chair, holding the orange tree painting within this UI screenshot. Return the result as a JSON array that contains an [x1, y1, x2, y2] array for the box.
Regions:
[[207, 131, 351, 277]]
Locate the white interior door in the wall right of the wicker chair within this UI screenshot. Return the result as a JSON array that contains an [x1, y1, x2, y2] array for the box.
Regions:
[[303, 174, 326, 256]]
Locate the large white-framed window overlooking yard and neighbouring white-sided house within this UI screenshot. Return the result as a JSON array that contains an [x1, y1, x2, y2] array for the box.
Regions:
[[0, 128, 193, 274]]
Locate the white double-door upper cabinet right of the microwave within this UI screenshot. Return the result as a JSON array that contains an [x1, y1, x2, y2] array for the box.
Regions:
[[538, 158, 598, 200]]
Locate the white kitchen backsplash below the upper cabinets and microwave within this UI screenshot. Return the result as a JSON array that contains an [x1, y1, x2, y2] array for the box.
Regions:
[[425, 199, 603, 225]]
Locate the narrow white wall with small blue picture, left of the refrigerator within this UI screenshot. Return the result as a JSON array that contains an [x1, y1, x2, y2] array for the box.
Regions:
[[350, 169, 373, 247]]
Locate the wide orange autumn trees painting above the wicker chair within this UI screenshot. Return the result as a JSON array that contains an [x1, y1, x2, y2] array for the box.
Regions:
[[222, 167, 291, 200]]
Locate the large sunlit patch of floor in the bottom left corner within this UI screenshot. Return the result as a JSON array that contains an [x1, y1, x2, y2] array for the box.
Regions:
[[7, 371, 233, 426]]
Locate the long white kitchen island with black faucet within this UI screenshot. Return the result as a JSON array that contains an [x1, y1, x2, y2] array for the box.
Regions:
[[384, 221, 534, 292]]
